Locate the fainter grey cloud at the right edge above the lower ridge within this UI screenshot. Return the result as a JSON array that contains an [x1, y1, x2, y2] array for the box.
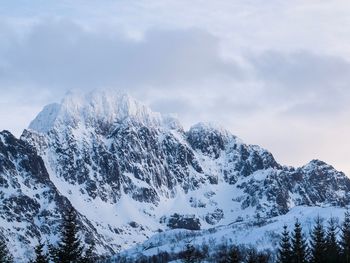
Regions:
[[250, 50, 350, 117]]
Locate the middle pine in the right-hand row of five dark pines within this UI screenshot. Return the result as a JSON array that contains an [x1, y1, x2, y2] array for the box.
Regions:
[[310, 216, 326, 263]]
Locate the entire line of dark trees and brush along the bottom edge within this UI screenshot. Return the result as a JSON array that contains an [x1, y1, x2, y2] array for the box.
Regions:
[[0, 212, 350, 263]]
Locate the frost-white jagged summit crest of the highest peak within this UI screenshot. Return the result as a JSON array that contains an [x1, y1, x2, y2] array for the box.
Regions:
[[29, 90, 179, 133]]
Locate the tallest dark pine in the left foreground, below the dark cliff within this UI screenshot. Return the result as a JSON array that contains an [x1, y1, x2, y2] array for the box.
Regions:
[[50, 208, 83, 263]]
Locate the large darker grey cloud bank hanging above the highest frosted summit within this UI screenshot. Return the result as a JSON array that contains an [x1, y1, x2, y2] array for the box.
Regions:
[[0, 20, 240, 93]]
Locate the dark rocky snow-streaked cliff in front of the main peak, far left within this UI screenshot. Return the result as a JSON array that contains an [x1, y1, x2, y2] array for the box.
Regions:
[[0, 131, 112, 260]]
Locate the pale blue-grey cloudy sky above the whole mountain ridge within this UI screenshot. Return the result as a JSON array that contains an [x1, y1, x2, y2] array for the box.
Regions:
[[0, 0, 350, 175]]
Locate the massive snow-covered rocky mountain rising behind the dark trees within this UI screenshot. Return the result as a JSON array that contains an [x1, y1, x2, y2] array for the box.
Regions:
[[0, 91, 350, 258]]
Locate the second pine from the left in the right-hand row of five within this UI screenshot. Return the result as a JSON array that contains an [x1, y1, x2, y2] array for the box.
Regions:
[[291, 219, 307, 263]]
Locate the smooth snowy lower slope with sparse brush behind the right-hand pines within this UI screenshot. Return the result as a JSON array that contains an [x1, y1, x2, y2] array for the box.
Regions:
[[113, 206, 346, 263]]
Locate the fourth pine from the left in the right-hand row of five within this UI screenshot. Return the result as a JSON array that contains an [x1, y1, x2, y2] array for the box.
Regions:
[[326, 218, 340, 263]]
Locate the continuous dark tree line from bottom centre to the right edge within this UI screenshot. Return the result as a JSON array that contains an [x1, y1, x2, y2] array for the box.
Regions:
[[111, 211, 350, 263]]
